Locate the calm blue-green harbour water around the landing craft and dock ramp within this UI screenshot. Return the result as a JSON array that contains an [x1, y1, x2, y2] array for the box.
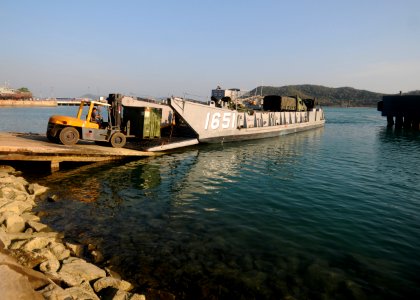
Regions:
[[0, 107, 420, 299]]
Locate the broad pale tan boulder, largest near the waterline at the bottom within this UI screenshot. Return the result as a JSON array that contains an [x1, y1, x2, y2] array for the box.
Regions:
[[58, 257, 106, 286]]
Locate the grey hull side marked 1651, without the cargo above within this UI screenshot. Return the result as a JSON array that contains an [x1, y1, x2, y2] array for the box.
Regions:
[[170, 98, 325, 143]]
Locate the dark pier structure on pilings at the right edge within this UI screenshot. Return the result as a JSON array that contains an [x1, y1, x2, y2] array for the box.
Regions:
[[378, 95, 420, 130]]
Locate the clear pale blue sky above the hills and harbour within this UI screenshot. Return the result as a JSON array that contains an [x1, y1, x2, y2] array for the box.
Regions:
[[0, 0, 420, 100]]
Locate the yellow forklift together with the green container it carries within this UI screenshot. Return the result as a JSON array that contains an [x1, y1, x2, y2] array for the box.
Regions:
[[47, 94, 162, 148]]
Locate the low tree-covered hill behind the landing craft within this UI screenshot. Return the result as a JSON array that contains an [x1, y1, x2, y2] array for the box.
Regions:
[[250, 84, 420, 106]]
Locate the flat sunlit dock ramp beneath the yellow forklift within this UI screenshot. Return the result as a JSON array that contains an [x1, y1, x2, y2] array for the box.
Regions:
[[0, 132, 159, 172]]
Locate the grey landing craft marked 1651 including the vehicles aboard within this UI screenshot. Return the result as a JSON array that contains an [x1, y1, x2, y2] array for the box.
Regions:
[[169, 88, 325, 143]]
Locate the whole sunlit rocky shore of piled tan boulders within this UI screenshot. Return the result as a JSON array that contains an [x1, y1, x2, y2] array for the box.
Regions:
[[0, 166, 146, 300]]
